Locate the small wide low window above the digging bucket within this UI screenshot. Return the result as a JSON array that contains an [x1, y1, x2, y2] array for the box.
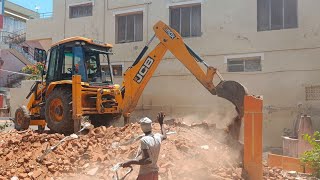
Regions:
[[227, 56, 262, 72]]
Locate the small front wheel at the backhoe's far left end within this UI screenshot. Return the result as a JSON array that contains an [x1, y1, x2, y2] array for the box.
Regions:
[[14, 106, 30, 131]]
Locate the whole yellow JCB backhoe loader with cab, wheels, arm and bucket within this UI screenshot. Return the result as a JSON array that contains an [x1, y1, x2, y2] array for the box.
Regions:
[[15, 21, 247, 139]]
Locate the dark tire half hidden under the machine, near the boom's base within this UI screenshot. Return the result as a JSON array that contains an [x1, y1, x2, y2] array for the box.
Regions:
[[89, 114, 121, 128]]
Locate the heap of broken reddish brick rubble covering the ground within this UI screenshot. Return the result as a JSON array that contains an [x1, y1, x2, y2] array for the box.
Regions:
[[0, 121, 314, 180]]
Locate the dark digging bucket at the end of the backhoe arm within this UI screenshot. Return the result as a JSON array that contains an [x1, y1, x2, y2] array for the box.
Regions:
[[216, 81, 248, 119]]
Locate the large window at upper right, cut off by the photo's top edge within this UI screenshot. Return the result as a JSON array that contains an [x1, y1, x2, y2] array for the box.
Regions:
[[257, 0, 298, 31]]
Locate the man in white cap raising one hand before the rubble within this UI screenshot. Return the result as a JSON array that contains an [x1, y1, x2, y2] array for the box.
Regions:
[[122, 112, 167, 180]]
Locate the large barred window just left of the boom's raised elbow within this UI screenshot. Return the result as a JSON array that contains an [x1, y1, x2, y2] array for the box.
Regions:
[[116, 12, 143, 43]]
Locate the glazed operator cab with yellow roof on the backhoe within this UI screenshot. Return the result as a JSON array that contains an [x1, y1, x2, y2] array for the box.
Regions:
[[46, 37, 113, 86]]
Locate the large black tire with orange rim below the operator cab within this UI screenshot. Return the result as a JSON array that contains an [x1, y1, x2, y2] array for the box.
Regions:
[[45, 88, 74, 134]]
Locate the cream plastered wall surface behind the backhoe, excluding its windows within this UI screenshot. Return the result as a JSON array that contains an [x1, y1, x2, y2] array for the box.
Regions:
[[27, 0, 320, 146]]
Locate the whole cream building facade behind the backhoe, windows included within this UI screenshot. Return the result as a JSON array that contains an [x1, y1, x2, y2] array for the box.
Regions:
[[27, 0, 320, 146]]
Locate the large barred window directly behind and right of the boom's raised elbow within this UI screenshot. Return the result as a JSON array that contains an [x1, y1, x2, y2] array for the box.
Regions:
[[170, 4, 201, 37]]
